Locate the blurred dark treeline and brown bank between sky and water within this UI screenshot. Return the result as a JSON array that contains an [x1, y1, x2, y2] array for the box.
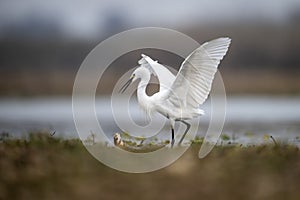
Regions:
[[0, 23, 300, 96]]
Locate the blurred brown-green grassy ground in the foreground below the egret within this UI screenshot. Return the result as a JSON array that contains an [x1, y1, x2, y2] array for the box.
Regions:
[[0, 134, 300, 200]]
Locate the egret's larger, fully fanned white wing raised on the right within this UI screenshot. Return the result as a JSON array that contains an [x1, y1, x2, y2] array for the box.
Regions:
[[168, 38, 231, 108]]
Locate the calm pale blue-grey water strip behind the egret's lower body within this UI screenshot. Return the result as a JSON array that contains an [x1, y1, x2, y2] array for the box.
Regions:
[[0, 96, 300, 143]]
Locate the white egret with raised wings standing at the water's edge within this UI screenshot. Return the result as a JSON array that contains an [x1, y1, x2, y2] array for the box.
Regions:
[[119, 37, 231, 147]]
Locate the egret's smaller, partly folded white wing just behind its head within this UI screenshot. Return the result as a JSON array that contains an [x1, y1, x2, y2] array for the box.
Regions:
[[139, 54, 175, 91]]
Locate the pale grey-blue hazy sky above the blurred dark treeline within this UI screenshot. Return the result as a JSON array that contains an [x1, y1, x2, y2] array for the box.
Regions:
[[0, 0, 300, 36]]
